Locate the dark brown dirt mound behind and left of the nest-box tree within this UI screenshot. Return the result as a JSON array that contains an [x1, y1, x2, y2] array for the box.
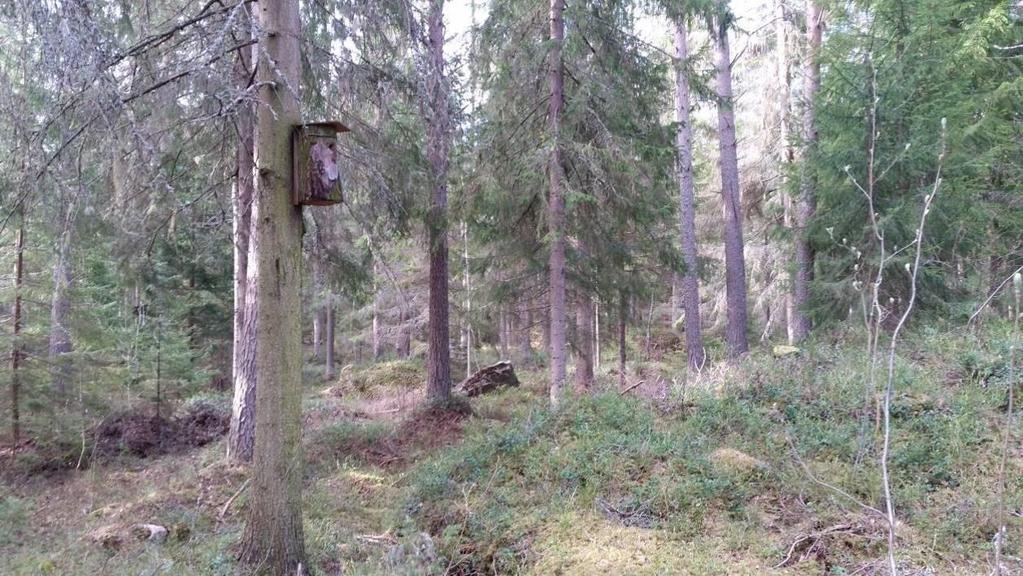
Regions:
[[90, 402, 230, 457]]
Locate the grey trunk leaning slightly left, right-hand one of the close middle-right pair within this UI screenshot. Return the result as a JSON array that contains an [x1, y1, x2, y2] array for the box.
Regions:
[[711, 7, 750, 358]]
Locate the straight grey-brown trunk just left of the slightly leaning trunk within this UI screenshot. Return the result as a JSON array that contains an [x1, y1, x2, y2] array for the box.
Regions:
[[675, 19, 704, 370]]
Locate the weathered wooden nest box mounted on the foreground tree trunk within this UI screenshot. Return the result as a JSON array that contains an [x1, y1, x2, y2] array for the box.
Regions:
[[292, 122, 348, 206]]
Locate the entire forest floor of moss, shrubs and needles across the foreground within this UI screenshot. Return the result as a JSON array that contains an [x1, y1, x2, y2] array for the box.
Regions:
[[0, 330, 1023, 575]]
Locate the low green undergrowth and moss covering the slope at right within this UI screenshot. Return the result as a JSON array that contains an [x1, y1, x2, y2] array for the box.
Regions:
[[386, 327, 1023, 574]]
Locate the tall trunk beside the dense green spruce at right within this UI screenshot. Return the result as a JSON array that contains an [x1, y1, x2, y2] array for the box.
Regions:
[[790, 0, 824, 343]]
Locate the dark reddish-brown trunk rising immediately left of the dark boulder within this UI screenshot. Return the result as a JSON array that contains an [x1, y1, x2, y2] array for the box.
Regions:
[[427, 0, 451, 402]]
